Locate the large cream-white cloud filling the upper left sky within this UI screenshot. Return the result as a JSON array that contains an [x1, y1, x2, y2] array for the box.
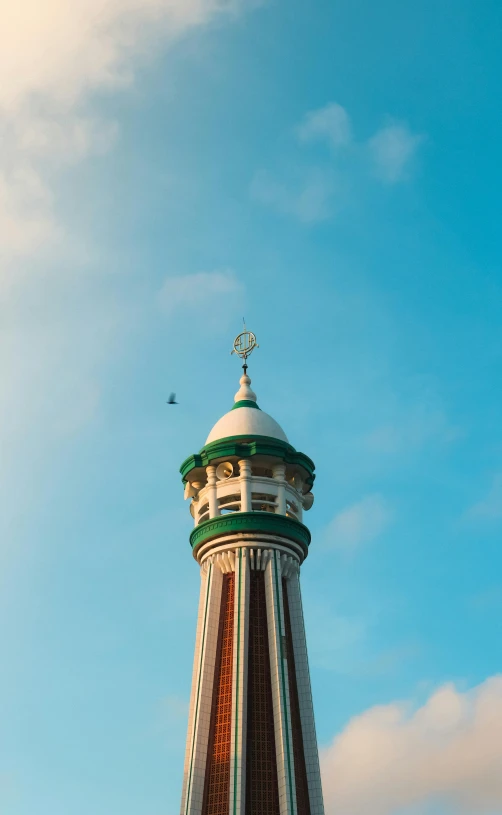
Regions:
[[0, 0, 251, 548]]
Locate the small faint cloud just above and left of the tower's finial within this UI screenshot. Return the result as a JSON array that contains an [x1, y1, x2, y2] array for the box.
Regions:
[[159, 270, 243, 314]]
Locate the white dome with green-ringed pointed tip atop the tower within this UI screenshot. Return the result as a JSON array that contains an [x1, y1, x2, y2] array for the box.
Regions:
[[206, 373, 288, 444]]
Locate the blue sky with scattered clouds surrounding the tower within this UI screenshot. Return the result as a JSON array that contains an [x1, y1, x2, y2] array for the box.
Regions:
[[0, 0, 502, 815]]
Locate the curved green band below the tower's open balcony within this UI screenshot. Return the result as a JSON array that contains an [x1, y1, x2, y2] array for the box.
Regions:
[[190, 512, 311, 549]]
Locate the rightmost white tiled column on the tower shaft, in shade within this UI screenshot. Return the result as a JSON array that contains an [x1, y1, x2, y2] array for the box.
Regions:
[[288, 566, 324, 815]]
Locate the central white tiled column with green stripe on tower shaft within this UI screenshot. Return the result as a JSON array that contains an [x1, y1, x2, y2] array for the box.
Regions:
[[229, 548, 249, 815]]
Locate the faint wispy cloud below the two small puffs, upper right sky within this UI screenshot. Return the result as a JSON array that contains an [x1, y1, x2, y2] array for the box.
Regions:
[[251, 170, 333, 224]]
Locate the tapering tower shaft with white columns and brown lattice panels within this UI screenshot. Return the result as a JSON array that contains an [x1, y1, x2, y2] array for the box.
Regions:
[[181, 536, 324, 815]]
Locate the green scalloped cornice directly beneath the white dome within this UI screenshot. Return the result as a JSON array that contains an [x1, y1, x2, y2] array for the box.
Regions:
[[180, 436, 315, 489]]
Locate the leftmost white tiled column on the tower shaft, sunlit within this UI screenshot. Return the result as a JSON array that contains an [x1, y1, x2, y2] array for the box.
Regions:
[[181, 561, 223, 815]]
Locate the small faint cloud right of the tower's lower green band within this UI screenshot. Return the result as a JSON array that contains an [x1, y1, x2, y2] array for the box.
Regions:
[[325, 494, 392, 548]]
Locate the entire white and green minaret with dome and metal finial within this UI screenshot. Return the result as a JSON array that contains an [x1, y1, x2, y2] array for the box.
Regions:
[[181, 331, 324, 815]]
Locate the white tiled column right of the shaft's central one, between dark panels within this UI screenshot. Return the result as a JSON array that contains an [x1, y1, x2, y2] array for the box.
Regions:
[[265, 550, 297, 815]]
